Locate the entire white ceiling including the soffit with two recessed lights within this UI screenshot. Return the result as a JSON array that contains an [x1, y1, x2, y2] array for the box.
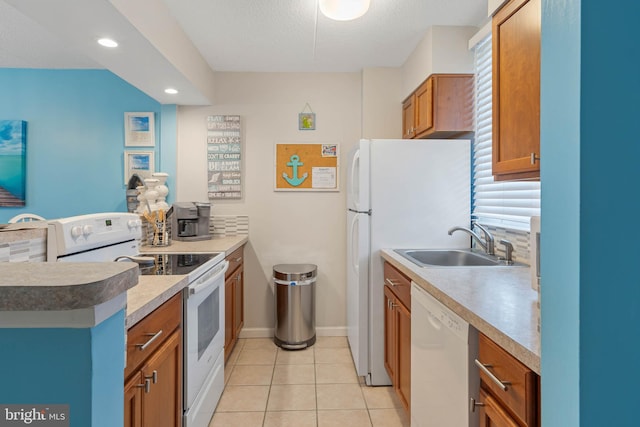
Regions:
[[0, 0, 487, 105]]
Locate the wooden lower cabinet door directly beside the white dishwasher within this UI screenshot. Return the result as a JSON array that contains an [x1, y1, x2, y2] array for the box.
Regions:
[[394, 302, 411, 411]]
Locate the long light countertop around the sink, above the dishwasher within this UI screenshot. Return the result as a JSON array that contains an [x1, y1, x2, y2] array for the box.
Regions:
[[382, 249, 540, 374]]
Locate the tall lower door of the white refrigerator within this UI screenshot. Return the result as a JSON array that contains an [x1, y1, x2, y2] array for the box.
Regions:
[[347, 211, 370, 376]]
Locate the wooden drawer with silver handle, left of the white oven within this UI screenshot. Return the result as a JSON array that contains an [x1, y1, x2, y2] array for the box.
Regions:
[[124, 293, 182, 378]]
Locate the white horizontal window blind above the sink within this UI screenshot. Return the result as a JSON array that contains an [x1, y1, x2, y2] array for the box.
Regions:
[[472, 35, 540, 230]]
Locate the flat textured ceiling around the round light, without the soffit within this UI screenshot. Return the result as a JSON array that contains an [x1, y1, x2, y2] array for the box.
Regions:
[[163, 0, 487, 72]]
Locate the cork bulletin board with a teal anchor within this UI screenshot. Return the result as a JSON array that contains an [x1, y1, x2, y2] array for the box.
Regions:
[[274, 144, 340, 191]]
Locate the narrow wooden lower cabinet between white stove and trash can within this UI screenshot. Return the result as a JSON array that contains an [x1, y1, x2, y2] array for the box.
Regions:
[[224, 246, 244, 360]]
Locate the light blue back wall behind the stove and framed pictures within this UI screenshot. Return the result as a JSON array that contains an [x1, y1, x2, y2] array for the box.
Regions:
[[0, 68, 176, 223]]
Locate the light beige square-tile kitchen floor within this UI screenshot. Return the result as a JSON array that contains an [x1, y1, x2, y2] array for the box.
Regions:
[[209, 337, 410, 427]]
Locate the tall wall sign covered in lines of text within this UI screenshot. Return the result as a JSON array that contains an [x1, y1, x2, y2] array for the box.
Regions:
[[207, 115, 242, 199]]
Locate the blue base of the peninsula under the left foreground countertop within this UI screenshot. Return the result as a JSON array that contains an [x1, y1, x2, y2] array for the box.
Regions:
[[0, 310, 125, 427]]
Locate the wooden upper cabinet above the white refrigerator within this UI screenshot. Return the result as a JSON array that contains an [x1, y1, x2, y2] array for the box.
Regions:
[[402, 74, 473, 138]]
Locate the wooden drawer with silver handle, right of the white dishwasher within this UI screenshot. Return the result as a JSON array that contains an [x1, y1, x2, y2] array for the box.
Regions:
[[478, 334, 538, 427]]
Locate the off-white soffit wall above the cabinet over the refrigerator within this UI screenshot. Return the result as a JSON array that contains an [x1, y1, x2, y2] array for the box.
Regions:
[[402, 26, 478, 99]]
